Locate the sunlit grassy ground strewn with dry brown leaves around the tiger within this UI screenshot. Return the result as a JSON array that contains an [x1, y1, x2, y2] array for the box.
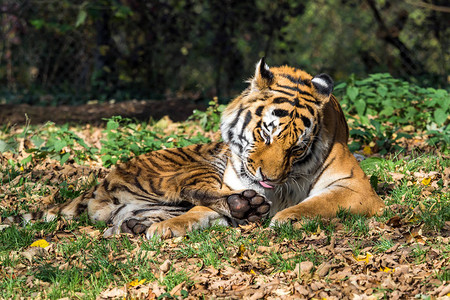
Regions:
[[0, 101, 450, 299]]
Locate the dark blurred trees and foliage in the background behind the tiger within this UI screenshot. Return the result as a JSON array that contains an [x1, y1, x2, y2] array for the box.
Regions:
[[0, 0, 450, 105]]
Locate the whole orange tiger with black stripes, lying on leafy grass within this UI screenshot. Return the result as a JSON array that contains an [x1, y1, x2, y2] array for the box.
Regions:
[[7, 58, 384, 239]]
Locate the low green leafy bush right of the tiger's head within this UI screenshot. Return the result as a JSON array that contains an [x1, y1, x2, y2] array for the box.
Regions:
[[335, 73, 450, 154]]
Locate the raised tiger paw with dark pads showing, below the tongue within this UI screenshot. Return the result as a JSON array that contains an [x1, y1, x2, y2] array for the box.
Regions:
[[227, 190, 270, 222]]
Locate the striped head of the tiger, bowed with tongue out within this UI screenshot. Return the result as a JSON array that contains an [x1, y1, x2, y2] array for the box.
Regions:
[[221, 58, 333, 188]]
